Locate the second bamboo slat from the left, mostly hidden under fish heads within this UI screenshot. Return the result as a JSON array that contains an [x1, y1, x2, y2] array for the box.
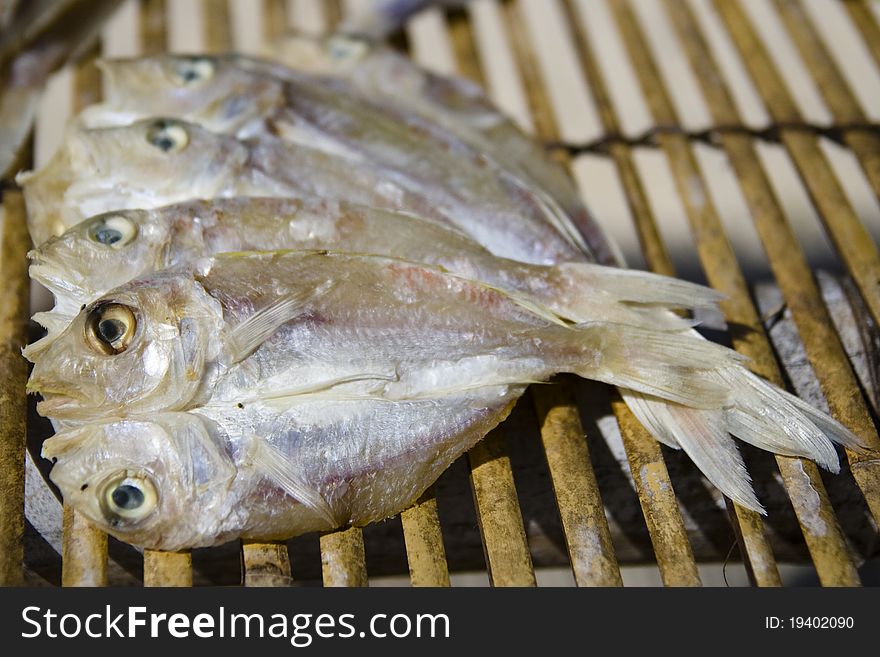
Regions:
[[61, 50, 107, 586]]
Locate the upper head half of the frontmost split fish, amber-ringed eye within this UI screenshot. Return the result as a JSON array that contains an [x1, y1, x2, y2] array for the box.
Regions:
[[28, 270, 223, 421]]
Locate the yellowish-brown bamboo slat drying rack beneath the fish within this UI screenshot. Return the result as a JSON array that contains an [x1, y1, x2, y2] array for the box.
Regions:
[[0, 0, 880, 586]]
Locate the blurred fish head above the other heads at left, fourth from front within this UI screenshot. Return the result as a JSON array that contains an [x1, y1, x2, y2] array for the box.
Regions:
[[83, 54, 284, 134]]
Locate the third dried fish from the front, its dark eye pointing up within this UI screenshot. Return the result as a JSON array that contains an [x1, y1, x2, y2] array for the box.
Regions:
[[18, 114, 581, 263]]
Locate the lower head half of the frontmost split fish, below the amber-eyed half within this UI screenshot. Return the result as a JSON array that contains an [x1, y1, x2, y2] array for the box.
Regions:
[[43, 413, 237, 550]]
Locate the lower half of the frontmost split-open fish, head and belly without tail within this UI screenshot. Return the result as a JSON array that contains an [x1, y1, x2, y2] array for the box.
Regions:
[[43, 388, 522, 550]]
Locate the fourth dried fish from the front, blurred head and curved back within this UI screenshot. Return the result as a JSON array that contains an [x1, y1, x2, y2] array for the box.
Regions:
[[74, 56, 593, 264]]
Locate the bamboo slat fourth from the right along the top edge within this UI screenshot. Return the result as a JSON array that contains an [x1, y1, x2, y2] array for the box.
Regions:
[[666, 0, 880, 556]]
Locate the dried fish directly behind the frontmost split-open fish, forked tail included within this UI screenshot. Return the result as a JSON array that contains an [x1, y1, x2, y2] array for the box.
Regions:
[[24, 197, 720, 361]]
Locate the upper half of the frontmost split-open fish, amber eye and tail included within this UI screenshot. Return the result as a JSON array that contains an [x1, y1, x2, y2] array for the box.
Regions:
[[29, 252, 859, 510]]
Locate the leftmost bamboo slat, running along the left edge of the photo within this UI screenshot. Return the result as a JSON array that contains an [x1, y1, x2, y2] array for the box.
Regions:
[[0, 189, 31, 586]]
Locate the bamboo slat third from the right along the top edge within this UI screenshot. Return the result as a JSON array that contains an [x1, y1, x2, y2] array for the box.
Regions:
[[713, 0, 880, 334]]
